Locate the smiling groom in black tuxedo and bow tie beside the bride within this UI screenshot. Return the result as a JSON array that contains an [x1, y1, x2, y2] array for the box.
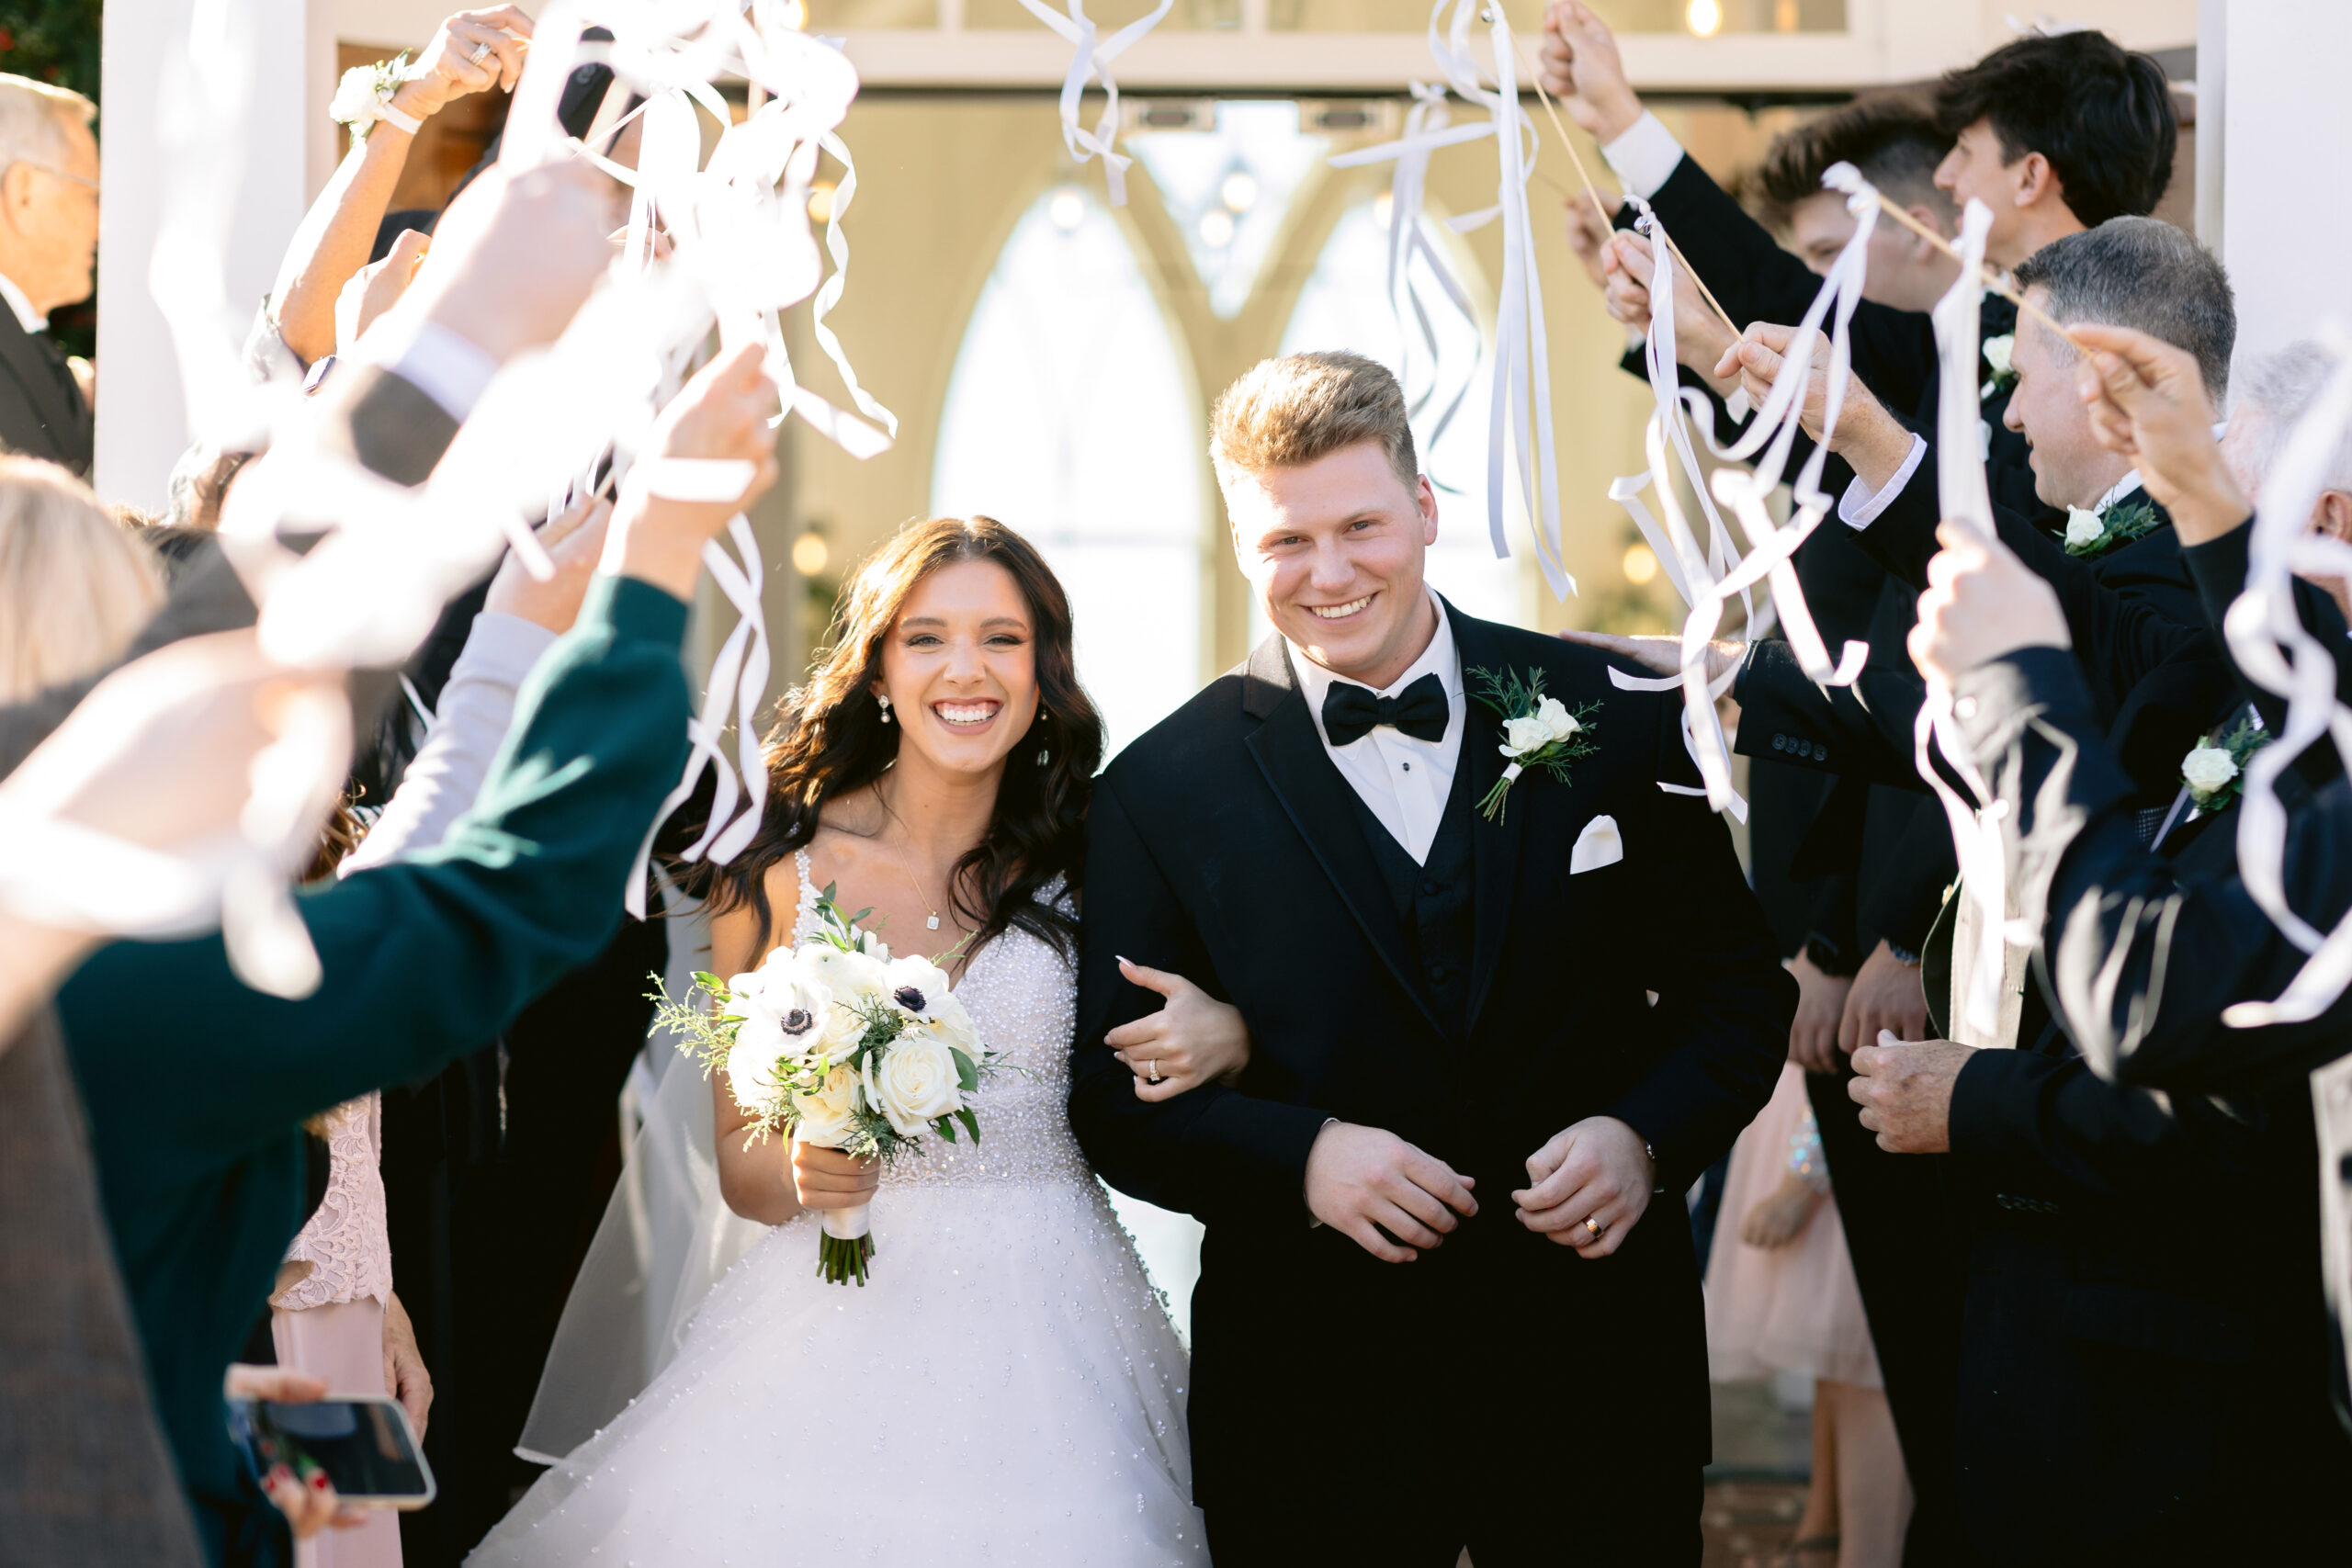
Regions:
[[1070, 353, 1797, 1568]]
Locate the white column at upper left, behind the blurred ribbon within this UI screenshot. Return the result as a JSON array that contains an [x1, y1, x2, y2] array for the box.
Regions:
[[92, 0, 334, 510]]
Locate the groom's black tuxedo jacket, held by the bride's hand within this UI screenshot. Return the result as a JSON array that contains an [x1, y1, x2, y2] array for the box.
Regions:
[[1070, 606, 1794, 1514]]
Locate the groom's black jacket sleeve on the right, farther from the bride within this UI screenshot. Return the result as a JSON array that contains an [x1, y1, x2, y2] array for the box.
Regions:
[[1604, 694, 1797, 1192]]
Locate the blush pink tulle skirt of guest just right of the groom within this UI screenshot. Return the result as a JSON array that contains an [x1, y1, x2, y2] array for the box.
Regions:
[[1708, 1063, 1884, 1389]]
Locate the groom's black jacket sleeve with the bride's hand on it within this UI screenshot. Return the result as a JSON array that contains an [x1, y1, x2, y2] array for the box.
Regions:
[[1070, 776, 1331, 1227]]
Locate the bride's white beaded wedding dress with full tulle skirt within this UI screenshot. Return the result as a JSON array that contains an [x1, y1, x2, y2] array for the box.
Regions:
[[466, 858, 1209, 1568]]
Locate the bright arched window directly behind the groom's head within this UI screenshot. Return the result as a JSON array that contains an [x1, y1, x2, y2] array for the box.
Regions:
[[1251, 193, 1533, 639]]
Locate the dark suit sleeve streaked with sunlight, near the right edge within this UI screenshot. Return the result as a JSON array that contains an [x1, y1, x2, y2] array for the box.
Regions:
[[1959, 649, 2352, 1093]]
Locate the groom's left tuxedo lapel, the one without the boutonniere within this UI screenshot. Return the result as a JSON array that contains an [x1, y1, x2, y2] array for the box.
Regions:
[[1242, 632, 1446, 1034]]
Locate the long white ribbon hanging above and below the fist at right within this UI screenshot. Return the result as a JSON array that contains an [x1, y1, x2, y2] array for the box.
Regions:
[[1912, 197, 2037, 1034]]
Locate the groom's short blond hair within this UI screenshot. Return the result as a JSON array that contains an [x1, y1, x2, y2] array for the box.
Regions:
[[1209, 353, 1420, 489]]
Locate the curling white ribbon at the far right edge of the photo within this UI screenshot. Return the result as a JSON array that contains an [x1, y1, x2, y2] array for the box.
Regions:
[[2222, 322, 2352, 1030]]
